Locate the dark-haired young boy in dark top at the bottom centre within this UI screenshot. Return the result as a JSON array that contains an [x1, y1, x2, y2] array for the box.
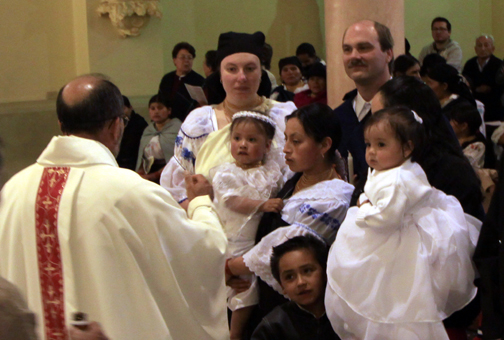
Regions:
[[251, 235, 339, 340]]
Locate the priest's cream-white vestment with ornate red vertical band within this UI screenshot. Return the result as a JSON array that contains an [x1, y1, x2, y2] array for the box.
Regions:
[[0, 136, 229, 340]]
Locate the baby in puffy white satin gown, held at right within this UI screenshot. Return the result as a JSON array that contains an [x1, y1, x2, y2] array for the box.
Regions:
[[325, 107, 481, 340]]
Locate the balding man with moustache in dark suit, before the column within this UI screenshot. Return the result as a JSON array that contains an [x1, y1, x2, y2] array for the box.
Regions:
[[334, 20, 394, 182]]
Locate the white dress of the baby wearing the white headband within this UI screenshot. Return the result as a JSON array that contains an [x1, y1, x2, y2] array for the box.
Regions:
[[210, 161, 283, 311]]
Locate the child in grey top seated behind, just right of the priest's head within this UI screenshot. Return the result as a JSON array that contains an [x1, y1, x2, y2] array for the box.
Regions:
[[136, 95, 182, 184]]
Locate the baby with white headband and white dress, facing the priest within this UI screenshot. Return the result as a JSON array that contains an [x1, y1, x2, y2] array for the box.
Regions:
[[210, 112, 283, 340]]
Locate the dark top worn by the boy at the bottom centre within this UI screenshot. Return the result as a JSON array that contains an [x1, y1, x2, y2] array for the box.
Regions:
[[251, 301, 340, 340]]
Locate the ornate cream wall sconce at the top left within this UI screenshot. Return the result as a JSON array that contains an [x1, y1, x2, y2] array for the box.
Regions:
[[97, 0, 162, 38]]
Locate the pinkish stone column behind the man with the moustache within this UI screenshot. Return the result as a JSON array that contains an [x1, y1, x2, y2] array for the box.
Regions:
[[324, 0, 404, 108]]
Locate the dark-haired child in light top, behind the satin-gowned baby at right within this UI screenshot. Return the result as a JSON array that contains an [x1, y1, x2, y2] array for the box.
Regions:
[[447, 102, 486, 170]]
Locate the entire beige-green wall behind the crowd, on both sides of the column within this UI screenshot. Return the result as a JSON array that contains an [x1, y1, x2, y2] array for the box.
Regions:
[[0, 0, 504, 185]]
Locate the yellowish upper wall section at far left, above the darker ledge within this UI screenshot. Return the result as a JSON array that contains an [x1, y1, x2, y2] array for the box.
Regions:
[[0, 0, 75, 103]]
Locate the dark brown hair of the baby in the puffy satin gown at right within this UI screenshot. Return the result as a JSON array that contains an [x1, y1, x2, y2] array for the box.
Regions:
[[364, 106, 425, 162]]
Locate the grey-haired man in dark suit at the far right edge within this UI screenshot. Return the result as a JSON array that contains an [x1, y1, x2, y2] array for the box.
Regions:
[[462, 35, 504, 122]]
